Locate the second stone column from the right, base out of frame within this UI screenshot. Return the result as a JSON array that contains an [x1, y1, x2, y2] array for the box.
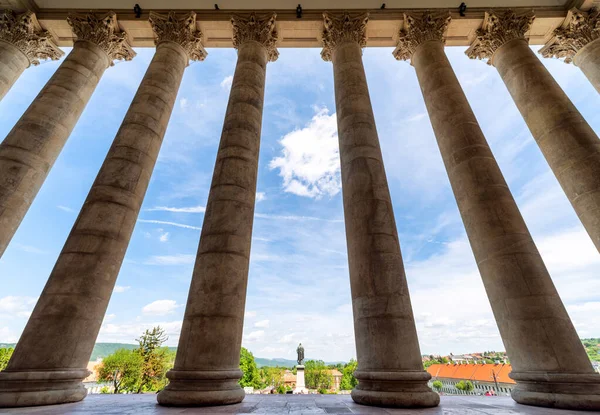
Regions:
[[466, 10, 600, 254]]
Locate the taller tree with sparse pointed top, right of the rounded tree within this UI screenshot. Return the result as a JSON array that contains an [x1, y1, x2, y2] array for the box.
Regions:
[[135, 326, 175, 393]]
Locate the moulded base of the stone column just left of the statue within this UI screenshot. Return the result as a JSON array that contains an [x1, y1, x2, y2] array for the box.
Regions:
[[157, 369, 246, 406]]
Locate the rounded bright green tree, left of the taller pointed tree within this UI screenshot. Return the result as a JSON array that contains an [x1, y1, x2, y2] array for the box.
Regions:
[[98, 349, 144, 393]]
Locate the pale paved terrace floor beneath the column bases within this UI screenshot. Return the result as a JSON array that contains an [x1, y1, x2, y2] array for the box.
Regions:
[[0, 394, 600, 415]]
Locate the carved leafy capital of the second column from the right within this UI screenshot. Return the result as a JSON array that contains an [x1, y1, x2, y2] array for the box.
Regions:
[[465, 10, 535, 65]]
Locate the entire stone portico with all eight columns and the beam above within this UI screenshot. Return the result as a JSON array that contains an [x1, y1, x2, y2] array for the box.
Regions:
[[0, 0, 600, 409]]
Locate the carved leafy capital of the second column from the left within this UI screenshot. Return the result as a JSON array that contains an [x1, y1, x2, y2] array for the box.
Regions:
[[67, 12, 136, 66]]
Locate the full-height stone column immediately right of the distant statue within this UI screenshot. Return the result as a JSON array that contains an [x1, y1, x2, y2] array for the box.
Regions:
[[321, 13, 439, 407]]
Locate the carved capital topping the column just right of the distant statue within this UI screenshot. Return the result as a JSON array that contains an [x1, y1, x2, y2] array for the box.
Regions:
[[321, 12, 369, 61]]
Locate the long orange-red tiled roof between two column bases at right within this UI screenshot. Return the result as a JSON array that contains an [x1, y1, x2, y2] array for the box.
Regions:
[[427, 363, 516, 384]]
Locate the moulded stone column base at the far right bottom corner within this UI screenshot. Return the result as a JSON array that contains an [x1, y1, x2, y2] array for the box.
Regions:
[[509, 372, 600, 411]]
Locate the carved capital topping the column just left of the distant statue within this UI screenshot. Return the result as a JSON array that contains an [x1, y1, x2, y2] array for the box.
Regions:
[[231, 13, 279, 62]]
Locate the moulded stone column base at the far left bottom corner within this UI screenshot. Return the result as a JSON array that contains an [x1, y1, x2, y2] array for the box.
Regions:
[[0, 369, 90, 408]]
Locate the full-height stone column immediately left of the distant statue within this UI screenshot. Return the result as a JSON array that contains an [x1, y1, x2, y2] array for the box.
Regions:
[[158, 14, 278, 406]]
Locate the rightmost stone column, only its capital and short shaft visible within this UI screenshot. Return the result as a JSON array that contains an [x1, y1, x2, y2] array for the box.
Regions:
[[540, 8, 600, 92]]
